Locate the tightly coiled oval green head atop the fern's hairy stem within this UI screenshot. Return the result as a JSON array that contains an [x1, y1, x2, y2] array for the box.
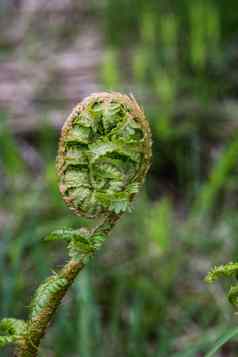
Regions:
[[57, 93, 151, 218]]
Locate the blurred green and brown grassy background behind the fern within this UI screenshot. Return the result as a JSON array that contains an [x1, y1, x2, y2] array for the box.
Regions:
[[0, 0, 238, 357]]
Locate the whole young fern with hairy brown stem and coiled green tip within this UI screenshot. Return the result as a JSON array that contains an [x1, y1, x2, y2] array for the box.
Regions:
[[0, 92, 151, 357]]
